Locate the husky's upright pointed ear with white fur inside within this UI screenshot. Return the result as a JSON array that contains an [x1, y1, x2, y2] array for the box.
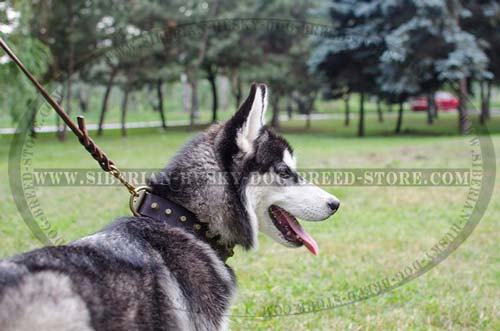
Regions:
[[232, 83, 267, 154]]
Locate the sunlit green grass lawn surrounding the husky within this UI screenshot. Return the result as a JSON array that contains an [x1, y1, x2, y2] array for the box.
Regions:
[[0, 114, 500, 331]]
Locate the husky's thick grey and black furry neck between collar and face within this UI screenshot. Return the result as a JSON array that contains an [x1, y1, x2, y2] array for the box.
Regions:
[[148, 124, 255, 249]]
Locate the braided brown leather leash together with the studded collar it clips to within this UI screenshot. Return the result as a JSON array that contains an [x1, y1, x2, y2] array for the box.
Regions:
[[0, 38, 234, 261]]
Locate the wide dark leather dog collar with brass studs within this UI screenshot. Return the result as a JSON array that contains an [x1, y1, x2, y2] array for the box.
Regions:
[[134, 191, 234, 262]]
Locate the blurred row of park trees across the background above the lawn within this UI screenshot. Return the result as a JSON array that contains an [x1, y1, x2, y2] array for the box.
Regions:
[[0, 0, 500, 139]]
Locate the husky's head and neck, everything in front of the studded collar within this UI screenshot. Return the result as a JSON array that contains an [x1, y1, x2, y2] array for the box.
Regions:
[[149, 84, 339, 254]]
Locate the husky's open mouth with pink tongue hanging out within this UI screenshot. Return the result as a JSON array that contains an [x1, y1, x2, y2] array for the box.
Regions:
[[269, 205, 319, 255]]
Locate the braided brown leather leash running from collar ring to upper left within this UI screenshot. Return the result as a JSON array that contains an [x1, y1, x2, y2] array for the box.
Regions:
[[0, 37, 137, 195]]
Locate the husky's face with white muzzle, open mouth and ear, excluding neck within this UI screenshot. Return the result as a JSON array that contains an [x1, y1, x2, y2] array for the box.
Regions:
[[225, 84, 340, 255]]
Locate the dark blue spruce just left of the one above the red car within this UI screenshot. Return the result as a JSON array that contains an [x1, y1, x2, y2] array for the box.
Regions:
[[309, 0, 385, 137]]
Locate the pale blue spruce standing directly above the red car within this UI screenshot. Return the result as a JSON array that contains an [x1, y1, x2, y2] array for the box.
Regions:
[[379, 1, 487, 134]]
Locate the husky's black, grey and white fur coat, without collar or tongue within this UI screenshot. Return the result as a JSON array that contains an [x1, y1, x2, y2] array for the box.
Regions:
[[0, 84, 339, 331]]
